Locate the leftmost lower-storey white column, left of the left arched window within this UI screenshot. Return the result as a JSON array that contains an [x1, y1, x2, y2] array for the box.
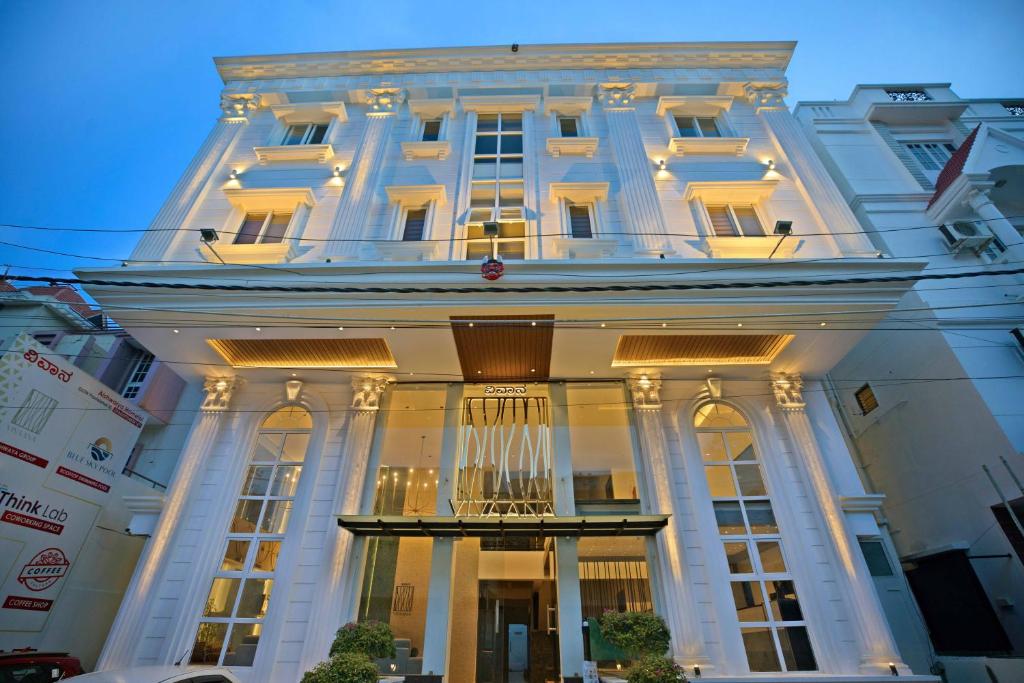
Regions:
[[96, 377, 240, 671]]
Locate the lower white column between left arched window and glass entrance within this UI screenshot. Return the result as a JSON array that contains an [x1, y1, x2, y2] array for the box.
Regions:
[[299, 376, 388, 671]]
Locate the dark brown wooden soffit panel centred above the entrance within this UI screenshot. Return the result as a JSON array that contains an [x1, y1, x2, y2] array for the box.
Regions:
[[451, 315, 555, 382]]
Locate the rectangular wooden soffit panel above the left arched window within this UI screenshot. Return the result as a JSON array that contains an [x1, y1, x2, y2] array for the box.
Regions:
[[207, 339, 397, 368]]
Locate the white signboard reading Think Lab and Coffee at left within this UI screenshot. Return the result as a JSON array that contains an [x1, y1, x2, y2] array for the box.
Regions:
[[0, 333, 144, 631]]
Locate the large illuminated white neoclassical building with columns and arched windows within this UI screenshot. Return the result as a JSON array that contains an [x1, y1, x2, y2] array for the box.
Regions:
[[83, 43, 942, 683]]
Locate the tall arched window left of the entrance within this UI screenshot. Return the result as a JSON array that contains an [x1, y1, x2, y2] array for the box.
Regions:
[[190, 405, 312, 667]]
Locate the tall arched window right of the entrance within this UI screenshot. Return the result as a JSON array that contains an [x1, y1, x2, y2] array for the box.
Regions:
[[693, 402, 817, 672]]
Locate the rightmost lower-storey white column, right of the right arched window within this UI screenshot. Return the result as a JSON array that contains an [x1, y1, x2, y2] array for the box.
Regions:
[[771, 373, 910, 675]]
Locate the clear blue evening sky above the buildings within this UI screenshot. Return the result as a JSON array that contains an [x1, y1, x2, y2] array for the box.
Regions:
[[0, 0, 1024, 274]]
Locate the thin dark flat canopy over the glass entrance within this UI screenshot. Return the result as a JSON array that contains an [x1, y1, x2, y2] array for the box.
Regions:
[[338, 515, 669, 538]]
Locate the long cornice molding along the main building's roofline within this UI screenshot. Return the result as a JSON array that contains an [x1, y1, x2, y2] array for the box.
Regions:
[[214, 41, 796, 83]]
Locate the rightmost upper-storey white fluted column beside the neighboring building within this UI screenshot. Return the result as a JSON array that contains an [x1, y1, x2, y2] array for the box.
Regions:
[[745, 85, 878, 257]]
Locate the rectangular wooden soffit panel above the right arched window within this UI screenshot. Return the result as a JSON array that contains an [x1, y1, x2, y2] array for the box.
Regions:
[[611, 335, 793, 368]]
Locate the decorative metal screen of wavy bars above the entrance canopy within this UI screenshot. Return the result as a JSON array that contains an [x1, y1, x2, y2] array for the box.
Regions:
[[452, 396, 554, 516]]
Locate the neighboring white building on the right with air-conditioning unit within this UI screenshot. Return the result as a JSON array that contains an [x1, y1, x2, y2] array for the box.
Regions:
[[796, 89, 1024, 680]]
